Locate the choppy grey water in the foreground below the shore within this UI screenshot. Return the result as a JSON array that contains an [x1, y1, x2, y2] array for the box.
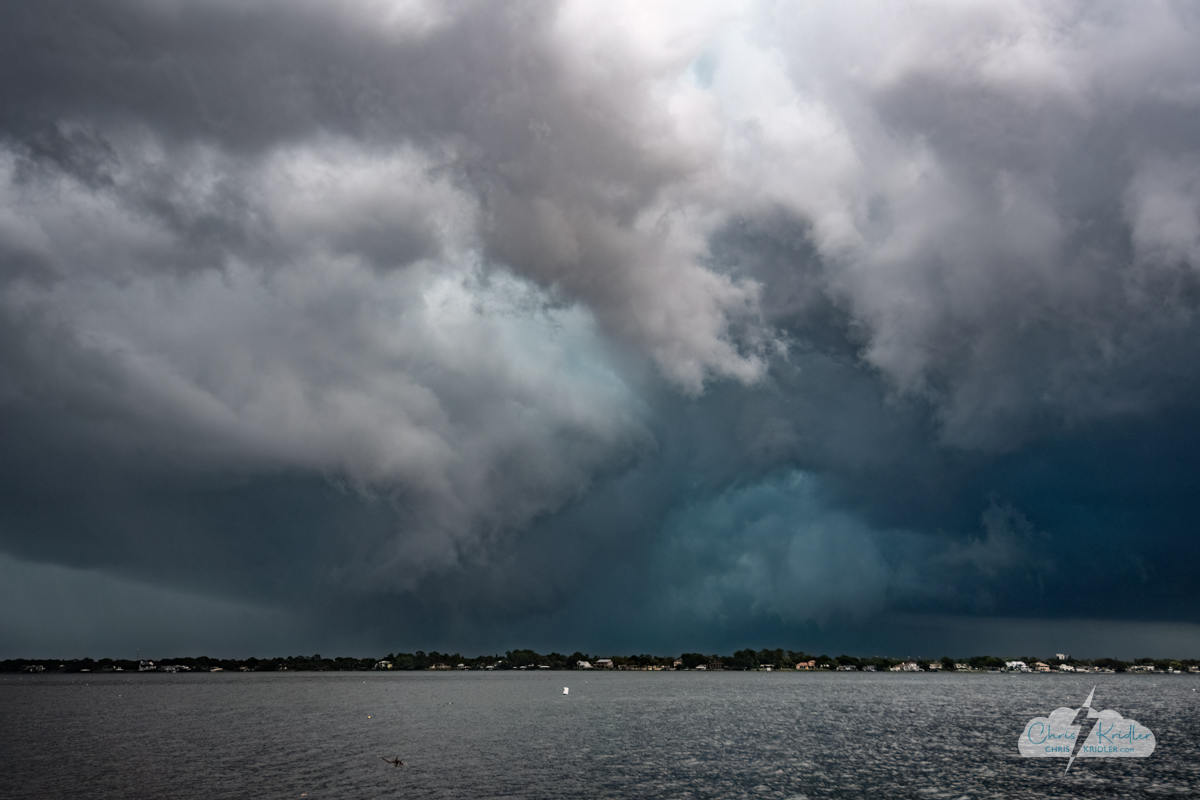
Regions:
[[0, 672, 1200, 800]]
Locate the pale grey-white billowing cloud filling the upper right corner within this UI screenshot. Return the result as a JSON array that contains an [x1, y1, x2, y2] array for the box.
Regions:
[[648, 0, 1200, 447]]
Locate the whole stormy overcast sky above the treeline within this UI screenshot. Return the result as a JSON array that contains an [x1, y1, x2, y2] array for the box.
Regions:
[[0, 0, 1200, 657]]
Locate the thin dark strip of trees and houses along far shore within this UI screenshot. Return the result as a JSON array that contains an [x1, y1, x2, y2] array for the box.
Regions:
[[7, 649, 1200, 674]]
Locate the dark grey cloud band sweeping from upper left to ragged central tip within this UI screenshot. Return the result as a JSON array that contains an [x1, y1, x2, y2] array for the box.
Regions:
[[5, 2, 761, 383]]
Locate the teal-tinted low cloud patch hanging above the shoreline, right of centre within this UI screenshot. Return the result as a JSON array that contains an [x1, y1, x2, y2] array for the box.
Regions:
[[661, 473, 1055, 625]]
